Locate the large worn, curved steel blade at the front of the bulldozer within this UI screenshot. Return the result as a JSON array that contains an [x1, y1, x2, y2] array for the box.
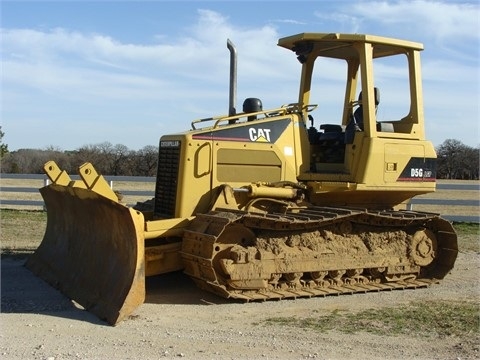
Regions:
[[26, 162, 145, 325]]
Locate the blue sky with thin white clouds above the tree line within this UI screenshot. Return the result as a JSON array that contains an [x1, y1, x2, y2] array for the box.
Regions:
[[0, 0, 480, 150]]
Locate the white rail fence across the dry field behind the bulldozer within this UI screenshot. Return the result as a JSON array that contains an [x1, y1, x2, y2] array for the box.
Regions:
[[0, 174, 480, 223]]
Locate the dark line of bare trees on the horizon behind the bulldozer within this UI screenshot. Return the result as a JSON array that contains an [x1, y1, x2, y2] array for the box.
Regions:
[[0, 135, 480, 180]]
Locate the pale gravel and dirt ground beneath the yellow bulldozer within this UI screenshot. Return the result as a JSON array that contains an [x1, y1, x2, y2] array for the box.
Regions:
[[0, 252, 480, 360]]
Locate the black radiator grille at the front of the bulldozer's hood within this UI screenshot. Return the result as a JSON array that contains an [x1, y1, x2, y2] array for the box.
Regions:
[[154, 141, 181, 218]]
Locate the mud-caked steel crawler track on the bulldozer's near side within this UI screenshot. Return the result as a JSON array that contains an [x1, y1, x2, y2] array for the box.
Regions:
[[182, 207, 458, 301]]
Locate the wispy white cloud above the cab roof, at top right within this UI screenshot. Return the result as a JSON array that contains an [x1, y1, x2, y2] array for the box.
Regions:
[[315, 0, 480, 48]]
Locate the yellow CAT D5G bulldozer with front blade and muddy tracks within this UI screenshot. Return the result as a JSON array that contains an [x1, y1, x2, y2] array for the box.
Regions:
[[26, 33, 458, 325]]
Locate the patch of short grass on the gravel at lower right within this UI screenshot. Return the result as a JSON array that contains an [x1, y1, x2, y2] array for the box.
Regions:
[[265, 301, 480, 338]]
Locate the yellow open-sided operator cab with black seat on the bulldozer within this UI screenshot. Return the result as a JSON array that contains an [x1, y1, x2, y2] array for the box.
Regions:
[[278, 33, 425, 176]]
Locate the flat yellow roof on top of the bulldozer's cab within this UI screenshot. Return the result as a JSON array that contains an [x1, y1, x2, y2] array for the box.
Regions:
[[278, 33, 423, 59]]
